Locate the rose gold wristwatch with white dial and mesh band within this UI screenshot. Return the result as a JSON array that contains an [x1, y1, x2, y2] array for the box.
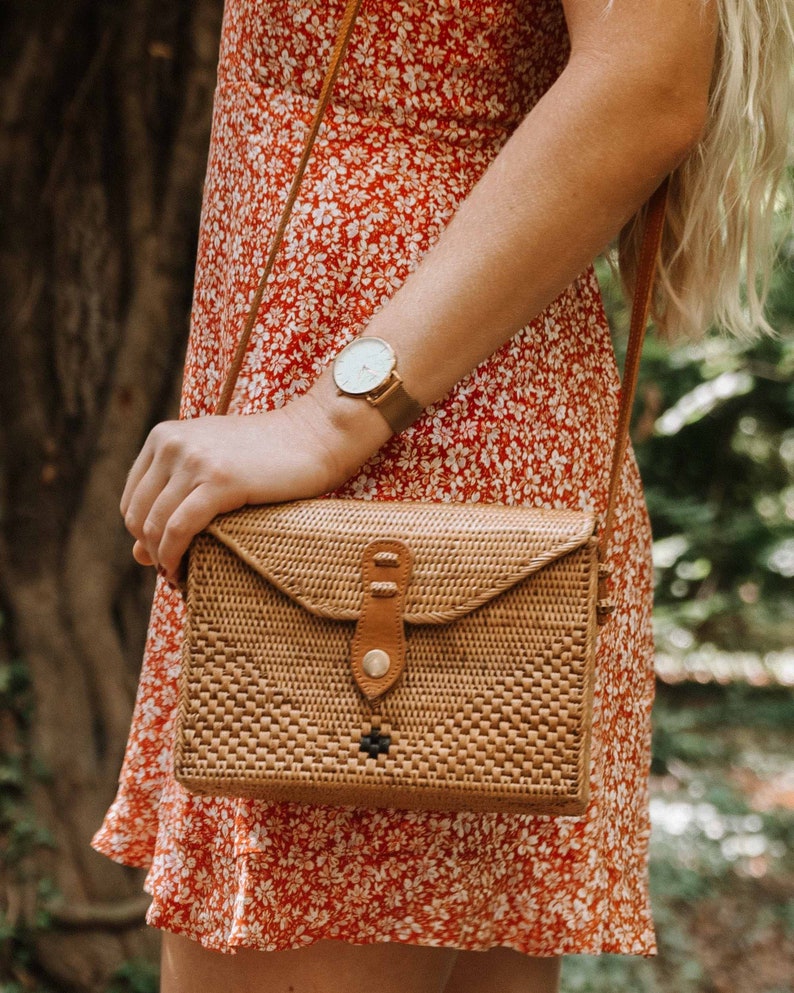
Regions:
[[333, 335, 422, 434]]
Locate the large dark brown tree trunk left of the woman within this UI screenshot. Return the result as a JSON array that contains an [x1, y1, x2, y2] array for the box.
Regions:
[[0, 0, 222, 991]]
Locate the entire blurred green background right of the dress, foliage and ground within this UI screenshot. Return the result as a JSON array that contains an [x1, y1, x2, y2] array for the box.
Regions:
[[563, 203, 794, 993]]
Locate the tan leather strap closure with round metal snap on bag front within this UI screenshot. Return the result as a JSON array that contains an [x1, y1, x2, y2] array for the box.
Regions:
[[350, 538, 411, 704]]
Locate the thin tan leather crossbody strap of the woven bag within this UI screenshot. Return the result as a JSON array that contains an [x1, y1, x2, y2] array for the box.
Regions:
[[215, 0, 667, 559]]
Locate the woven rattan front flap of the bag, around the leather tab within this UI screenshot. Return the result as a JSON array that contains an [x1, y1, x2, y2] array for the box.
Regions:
[[206, 499, 596, 624]]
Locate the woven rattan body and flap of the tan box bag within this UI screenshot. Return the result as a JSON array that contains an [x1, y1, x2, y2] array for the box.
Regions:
[[176, 500, 597, 814]]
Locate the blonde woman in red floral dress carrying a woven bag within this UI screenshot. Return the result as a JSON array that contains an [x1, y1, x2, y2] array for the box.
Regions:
[[95, 0, 790, 993]]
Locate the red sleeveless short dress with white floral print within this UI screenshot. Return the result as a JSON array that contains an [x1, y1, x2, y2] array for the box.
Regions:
[[94, 0, 654, 955]]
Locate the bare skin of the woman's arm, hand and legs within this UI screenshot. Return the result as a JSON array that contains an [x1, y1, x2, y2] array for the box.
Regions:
[[121, 0, 716, 993]]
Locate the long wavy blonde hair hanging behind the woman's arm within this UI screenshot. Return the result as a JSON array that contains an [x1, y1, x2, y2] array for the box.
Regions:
[[618, 0, 794, 338]]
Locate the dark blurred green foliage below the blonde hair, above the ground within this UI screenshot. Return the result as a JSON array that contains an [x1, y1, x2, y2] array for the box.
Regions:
[[599, 225, 794, 653]]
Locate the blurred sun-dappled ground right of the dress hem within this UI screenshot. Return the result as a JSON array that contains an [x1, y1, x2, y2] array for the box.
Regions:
[[563, 683, 794, 993]]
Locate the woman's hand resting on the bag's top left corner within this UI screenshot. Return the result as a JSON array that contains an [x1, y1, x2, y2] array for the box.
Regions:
[[121, 392, 362, 581]]
